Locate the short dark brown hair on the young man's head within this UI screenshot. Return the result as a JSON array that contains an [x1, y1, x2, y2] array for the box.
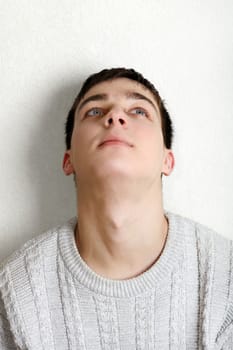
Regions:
[[65, 68, 174, 150]]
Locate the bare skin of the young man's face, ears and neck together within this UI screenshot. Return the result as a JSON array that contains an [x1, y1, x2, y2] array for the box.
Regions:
[[63, 78, 174, 280]]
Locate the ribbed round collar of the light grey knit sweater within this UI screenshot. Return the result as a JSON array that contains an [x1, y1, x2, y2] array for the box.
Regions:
[[58, 212, 185, 298]]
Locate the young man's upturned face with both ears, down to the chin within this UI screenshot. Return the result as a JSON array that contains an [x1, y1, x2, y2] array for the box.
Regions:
[[63, 78, 174, 189]]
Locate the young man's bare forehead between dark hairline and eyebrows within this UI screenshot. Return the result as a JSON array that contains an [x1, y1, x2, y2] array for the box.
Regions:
[[80, 78, 157, 104]]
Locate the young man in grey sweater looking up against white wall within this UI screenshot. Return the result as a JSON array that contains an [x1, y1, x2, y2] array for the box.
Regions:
[[0, 68, 233, 350]]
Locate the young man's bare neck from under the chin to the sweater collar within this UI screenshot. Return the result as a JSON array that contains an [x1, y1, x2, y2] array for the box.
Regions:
[[76, 182, 168, 279]]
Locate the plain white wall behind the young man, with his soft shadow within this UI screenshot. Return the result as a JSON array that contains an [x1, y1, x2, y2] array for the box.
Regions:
[[0, 0, 233, 259]]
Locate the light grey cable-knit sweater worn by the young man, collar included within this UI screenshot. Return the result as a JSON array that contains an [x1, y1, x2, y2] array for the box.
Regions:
[[0, 212, 233, 350]]
